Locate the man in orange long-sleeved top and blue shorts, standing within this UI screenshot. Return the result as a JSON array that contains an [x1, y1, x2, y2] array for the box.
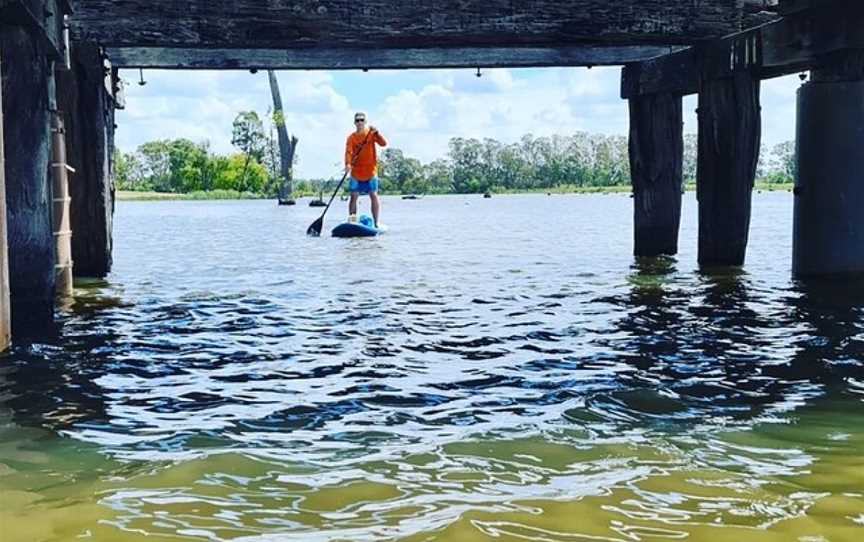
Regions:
[[345, 112, 387, 228]]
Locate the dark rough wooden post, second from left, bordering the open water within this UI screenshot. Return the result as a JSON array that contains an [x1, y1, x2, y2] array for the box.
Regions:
[[57, 43, 114, 277]]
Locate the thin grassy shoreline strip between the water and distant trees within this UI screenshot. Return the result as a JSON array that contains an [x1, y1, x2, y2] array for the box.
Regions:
[[116, 182, 794, 201]]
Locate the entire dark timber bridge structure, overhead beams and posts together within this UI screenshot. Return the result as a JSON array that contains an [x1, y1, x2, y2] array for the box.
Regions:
[[6, 0, 864, 350]]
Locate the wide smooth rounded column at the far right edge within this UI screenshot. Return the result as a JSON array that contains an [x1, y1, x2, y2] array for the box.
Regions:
[[792, 51, 864, 277]]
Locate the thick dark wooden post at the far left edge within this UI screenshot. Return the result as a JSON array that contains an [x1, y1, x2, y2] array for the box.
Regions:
[[0, 26, 54, 336]]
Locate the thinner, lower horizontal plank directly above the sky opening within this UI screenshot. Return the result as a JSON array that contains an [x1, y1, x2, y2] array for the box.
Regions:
[[106, 46, 669, 70]]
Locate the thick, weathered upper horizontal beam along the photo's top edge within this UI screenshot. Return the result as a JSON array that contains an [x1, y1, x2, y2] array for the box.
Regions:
[[71, 0, 776, 50]]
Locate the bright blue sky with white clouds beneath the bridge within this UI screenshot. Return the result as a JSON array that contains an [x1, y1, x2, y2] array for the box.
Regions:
[[116, 67, 800, 179]]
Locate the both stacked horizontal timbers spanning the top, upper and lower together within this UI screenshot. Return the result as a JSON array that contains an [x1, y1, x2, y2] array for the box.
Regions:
[[64, 0, 776, 69]]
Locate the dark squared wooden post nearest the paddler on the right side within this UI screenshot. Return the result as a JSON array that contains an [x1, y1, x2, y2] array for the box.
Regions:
[[629, 93, 684, 256]]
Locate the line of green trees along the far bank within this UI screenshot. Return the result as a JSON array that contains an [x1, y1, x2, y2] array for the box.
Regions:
[[115, 125, 795, 197]]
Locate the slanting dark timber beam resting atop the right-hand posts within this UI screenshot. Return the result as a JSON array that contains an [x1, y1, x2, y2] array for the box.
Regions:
[[621, 0, 864, 99]]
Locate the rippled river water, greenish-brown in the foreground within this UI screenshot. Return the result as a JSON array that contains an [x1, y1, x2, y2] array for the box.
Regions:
[[0, 193, 864, 542]]
